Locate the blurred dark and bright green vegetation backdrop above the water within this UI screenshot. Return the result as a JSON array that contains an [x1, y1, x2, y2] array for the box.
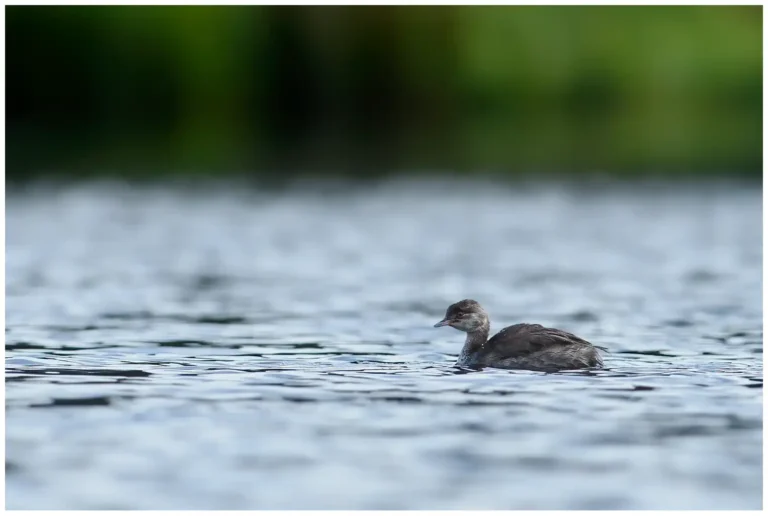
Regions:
[[6, 6, 762, 180]]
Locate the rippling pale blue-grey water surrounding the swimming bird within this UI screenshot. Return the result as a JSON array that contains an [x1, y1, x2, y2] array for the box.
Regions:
[[6, 182, 763, 509]]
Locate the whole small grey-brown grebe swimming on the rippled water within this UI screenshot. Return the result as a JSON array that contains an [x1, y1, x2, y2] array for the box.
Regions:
[[435, 299, 603, 371]]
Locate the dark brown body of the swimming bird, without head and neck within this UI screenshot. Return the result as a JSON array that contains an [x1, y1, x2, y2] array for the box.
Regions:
[[472, 323, 603, 371]]
